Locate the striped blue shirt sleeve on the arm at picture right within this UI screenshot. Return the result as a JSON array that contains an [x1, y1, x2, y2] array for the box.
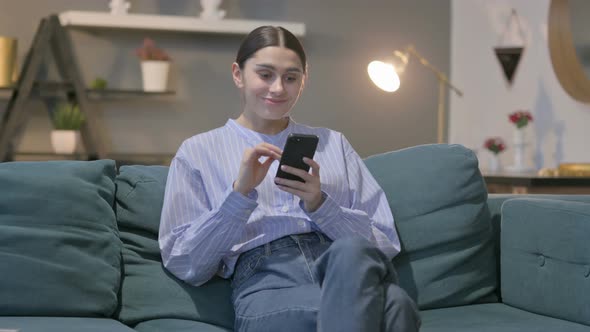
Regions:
[[301, 137, 400, 259]]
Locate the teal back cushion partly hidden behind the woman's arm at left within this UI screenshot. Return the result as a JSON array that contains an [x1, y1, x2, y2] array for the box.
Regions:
[[116, 165, 234, 328]]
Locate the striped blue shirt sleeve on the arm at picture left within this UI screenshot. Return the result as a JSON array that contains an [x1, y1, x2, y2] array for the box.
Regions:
[[159, 155, 258, 286]]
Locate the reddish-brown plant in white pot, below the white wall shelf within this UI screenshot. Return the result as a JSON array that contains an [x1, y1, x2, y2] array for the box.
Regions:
[[135, 38, 170, 92]]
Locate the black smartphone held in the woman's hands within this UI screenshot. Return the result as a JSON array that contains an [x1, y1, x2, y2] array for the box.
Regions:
[[277, 134, 319, 182]]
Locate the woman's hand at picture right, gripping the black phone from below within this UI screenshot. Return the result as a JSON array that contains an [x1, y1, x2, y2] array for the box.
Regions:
[[275, 157, 324, 212]]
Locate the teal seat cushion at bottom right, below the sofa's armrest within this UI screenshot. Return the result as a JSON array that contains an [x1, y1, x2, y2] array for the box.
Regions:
[[420, 303, 590, 332]]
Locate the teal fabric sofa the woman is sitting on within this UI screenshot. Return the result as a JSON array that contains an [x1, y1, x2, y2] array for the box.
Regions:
[[0, 144, 590, 332]]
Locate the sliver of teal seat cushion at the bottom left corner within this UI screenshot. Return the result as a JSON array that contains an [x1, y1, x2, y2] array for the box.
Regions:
[[0, 316, 134, 332]]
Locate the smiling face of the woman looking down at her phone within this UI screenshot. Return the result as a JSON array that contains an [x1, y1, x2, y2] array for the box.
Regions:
[[232, 46, 305, 120]]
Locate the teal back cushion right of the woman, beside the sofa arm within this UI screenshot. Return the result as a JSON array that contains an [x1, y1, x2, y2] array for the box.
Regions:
[[365, 144, 498, 309]]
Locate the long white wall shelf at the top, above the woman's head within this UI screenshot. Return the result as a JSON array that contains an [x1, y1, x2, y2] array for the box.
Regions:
[[59, 11, 305, 37]]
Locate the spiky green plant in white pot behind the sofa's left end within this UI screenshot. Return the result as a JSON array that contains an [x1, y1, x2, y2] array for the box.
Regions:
[[51, 102, 86, 154]]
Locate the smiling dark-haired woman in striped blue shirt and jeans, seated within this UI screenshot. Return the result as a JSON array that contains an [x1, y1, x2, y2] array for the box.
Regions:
[[159, 26, 419, 332]]
